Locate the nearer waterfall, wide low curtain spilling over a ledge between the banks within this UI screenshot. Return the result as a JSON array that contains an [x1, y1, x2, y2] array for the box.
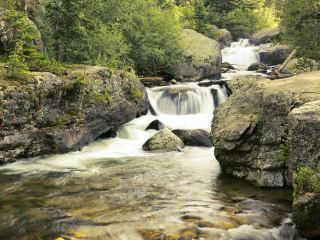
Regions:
[[148, 84, 227, 115]]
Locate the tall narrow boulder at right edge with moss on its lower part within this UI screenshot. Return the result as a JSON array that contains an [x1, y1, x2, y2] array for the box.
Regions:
[[288, 101, 320, 238]]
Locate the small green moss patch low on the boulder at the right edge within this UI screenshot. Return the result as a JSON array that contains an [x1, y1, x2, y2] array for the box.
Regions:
[[294, 166, 320, 195]]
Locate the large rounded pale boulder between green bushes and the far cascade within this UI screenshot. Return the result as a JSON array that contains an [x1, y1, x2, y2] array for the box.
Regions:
[[173, 29, 222, 81]]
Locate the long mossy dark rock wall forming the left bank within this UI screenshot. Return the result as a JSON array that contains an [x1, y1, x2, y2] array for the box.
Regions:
[[0, 70, 148, 164]]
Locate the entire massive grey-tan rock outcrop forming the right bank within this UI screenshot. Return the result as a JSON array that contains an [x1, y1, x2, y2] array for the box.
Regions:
[[211, 72, 320, 237]]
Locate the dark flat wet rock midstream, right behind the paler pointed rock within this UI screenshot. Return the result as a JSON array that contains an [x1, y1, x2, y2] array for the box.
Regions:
[[172, 129, 213, 147]]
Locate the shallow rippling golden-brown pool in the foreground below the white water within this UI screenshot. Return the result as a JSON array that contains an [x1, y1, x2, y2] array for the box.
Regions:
[[0, 146, 294, 239]]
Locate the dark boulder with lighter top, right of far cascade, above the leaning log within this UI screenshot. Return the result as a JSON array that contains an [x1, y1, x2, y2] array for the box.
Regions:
[[259, 45, 291, 65]]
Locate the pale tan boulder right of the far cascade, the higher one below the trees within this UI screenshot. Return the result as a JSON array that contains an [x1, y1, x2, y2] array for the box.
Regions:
[[249, 27, 281, 46]]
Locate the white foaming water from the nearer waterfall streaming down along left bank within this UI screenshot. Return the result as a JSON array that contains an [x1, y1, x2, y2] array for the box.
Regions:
[[0, 84, 227, 173]]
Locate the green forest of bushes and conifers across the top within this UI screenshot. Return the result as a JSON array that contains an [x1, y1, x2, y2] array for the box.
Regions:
[[0, 0, 320, 77]]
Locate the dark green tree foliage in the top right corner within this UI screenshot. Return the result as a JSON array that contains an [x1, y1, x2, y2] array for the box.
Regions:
[[282, 0, 320, 61]]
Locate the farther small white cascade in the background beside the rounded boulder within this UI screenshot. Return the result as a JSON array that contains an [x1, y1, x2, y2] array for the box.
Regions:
[[222, 39, 260, 71]]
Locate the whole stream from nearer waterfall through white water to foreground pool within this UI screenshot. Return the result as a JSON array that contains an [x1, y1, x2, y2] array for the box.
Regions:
[[0, 42, 296, 240]]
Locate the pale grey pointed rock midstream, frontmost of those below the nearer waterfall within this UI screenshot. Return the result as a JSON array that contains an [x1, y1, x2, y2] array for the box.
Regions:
[[142, 129, 184, 151]]
